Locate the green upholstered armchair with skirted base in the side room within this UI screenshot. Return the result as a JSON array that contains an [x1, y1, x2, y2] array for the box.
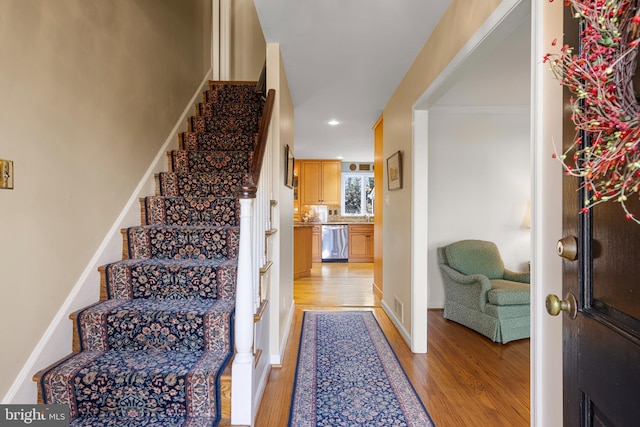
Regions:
[[438, 240, 530, 344]]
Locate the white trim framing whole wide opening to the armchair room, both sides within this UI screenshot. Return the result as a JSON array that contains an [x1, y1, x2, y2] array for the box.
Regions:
[[411, 0, 563, 427]]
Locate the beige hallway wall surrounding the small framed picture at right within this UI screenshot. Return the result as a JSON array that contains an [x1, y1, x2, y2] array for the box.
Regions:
[[383, 0, 500, 334]]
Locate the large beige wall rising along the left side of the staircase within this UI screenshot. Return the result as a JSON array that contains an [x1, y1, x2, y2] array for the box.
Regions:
[[0, 0, 211, 403]]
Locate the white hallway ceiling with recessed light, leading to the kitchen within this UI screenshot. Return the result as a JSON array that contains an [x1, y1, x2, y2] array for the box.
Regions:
[[254, 0, 450, 162]]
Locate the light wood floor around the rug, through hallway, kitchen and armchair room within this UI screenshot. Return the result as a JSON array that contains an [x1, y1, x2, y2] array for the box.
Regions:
[[256, 263, 529, 427]]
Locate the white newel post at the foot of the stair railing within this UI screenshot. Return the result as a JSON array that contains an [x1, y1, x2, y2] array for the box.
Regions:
[[231, 195, 255, 426]]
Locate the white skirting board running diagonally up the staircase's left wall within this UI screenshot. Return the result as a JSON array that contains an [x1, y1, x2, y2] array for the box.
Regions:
[[2, 69, 212, 404]]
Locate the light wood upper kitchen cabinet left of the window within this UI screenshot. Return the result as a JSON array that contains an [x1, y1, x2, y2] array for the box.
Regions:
[[298, 160, 342, 205]]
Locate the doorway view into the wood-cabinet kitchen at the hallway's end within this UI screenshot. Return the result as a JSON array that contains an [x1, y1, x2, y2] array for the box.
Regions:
[[293, 159, 382, 307]]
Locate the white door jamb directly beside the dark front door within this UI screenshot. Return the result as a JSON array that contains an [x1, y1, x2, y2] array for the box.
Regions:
[[531, 1, 564, 427]]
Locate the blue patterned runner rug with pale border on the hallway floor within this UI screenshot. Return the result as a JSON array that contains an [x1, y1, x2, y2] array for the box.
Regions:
[[289, 311, 435, 427]]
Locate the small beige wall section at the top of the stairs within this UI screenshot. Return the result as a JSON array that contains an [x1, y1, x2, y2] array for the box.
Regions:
[[229, 0, 266, 81]]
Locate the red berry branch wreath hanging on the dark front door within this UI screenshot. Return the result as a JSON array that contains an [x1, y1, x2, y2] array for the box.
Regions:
[[544, 0, 640, 224]]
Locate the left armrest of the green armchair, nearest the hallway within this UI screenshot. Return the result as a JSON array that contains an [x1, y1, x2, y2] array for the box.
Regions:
[[439, 264, 491, 311]]
